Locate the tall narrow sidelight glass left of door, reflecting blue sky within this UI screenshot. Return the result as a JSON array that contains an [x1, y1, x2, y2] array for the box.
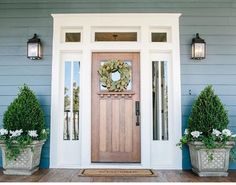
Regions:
[[63, 62, 80, 140]]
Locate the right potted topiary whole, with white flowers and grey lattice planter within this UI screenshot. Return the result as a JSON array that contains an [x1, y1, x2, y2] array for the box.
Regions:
[[179, 85, 236, 176]]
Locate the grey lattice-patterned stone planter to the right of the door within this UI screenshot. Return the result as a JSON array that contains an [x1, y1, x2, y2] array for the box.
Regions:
[[188, 142, 235, 176]]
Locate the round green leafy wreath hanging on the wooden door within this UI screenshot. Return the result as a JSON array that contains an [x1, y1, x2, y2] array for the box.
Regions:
[[98, 60, 131, 92]]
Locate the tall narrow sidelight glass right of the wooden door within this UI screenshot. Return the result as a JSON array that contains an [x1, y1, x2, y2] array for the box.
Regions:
[[152, 61, 169, 140]]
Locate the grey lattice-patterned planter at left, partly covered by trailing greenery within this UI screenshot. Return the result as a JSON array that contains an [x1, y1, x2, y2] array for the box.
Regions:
[[0, 140, 45, 175]]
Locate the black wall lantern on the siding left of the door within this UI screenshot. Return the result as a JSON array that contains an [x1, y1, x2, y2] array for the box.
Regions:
[[27, 34, 42, 60]]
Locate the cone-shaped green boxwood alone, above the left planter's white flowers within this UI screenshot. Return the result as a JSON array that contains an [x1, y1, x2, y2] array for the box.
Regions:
[[3, 85, 45, 134]]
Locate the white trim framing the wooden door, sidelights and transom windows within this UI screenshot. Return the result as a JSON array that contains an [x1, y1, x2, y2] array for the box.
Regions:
[[50, 13, 182, 169]]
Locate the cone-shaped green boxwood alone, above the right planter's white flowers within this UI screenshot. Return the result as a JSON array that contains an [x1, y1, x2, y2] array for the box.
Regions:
[[188, 85, 229, 137]]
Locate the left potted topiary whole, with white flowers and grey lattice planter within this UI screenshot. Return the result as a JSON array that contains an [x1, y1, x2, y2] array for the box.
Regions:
[[0, 85, 48, 175]]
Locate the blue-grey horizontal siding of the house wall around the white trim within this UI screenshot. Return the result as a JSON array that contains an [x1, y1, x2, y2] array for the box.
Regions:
[[0, 0, 236, 169]]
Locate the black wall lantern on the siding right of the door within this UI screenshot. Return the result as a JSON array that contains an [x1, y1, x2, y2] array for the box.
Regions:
[[192, 33, 206, 60]]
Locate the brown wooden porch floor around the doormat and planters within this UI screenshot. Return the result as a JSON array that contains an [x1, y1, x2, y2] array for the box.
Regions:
[[0, 169, 236, 182]]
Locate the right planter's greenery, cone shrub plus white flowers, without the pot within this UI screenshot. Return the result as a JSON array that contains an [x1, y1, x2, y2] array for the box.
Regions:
[[177, 85, 236, 152]]
